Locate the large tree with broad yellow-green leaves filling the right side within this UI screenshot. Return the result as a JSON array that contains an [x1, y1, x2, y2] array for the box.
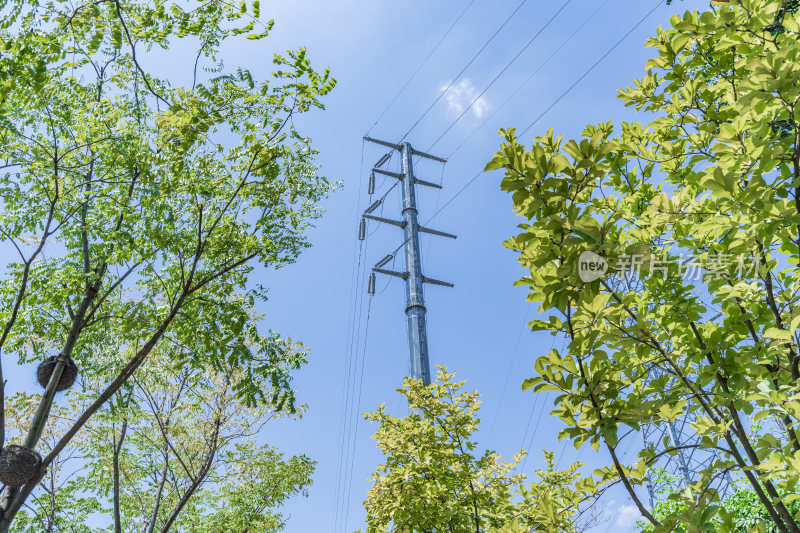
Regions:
[[487, 0, 800, 532]]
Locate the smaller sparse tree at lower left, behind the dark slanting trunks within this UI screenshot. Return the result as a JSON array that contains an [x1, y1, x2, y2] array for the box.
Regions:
[[3, 340, 314, 533]]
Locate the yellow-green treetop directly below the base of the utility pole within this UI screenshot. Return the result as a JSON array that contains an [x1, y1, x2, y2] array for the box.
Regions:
[[364, 368, 591, 533]]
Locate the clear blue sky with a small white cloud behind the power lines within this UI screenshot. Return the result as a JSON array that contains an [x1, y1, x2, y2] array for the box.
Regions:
[[4, 0, 707, 532]]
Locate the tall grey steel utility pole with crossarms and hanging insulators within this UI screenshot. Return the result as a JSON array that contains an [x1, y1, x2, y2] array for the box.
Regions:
[[359, 137, 456, 385]]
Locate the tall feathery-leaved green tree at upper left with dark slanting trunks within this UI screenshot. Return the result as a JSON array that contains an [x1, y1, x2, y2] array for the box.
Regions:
[[0, 0, 335, 531]]
